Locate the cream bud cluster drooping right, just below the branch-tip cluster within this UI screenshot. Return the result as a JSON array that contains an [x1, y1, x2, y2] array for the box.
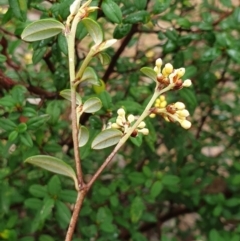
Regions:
[[150, 99, 192, 129]]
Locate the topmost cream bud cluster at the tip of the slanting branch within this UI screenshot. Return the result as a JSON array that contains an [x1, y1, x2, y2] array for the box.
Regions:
[[154, 58, 192, 90]]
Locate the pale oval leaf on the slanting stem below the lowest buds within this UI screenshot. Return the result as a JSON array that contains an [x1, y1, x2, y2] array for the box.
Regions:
[[91, 129, 122, 150]]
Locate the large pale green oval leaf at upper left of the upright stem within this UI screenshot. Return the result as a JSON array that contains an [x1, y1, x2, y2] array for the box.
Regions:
[[21, 19, 65, 42]]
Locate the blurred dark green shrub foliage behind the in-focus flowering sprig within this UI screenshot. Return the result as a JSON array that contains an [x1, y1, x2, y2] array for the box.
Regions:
[[0, 0, 240, 241]]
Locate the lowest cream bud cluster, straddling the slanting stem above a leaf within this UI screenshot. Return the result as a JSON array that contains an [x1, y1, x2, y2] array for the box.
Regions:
[[111, 108, 149, 137]]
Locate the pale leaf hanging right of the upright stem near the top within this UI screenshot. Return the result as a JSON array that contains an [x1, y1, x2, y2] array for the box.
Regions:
[[82, 18, 103, 45]]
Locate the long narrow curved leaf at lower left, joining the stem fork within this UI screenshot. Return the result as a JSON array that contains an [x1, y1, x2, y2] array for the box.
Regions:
[[24, 155, 78, 190]]
